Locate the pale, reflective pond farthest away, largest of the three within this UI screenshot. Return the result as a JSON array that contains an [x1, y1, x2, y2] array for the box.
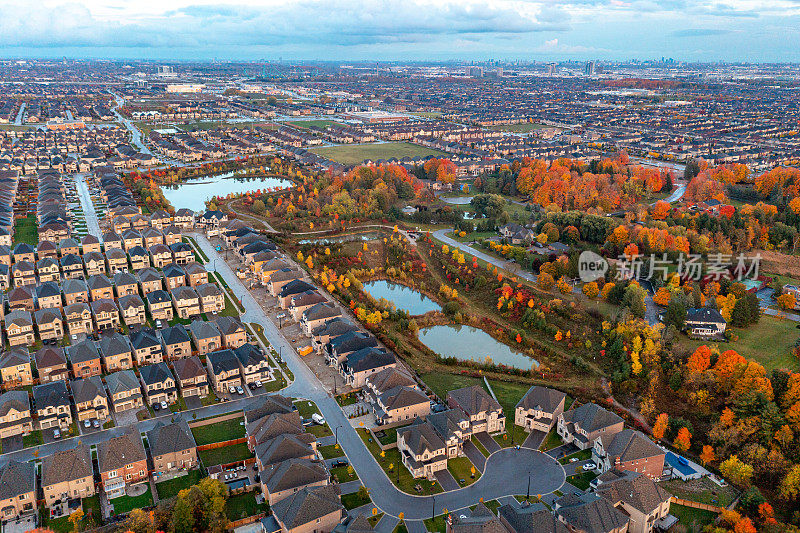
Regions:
[[162, 172, 292, 212]]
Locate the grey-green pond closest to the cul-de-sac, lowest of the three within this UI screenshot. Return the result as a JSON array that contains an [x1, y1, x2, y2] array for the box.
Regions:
[[419, 325, 539, 370]]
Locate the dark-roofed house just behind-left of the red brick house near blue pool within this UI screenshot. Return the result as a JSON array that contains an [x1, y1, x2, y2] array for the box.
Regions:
[[556, 403, 625, 450]]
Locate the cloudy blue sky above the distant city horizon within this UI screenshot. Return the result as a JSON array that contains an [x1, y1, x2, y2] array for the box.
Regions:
[[0, 0, 800, 62]]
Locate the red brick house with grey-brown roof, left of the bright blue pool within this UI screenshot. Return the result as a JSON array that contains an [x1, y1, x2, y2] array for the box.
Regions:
[[592, 429, 666, 481]]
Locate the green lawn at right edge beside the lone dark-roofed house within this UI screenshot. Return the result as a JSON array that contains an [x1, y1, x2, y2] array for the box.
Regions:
[[680, 315, 800, 372]]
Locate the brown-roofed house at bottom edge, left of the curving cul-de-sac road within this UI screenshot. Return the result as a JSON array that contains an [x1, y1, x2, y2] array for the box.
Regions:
[[272, 485, 344, 533]]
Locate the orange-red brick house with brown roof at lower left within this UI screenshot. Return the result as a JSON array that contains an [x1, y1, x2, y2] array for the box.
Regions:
[[97, 430, 148, 499]]
